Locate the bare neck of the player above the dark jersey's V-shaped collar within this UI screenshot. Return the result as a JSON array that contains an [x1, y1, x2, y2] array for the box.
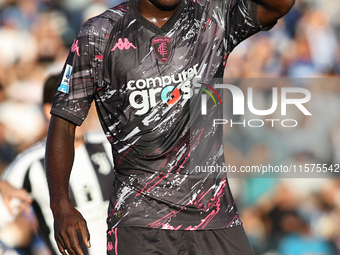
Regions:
[[136, 0, 180, 28]]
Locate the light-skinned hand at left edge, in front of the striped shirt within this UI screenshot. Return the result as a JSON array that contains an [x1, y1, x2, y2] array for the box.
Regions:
[[0, 181, 33, 215]]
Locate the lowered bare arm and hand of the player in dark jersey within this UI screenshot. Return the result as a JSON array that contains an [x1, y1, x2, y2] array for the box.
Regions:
[[45, 116, 90, 255]]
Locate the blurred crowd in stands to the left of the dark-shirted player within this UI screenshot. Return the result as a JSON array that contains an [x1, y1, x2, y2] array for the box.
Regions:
[[0, 0, 121, 170]]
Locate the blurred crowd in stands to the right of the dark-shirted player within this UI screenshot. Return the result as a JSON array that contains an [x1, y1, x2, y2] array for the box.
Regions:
[[225, 1, 340, 255]]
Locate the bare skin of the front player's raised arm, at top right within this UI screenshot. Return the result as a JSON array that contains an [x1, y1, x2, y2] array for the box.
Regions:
[[252, 0, 295, 27]]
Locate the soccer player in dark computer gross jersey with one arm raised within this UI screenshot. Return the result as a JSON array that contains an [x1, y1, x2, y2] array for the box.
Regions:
[[46, 0, 294, 255]]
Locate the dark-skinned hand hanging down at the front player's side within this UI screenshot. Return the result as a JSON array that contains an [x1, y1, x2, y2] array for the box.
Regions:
[[53, 201, 91, 255]]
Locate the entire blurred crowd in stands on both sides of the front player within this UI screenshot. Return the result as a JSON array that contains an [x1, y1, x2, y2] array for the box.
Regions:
[[0, 0, 340, 255]]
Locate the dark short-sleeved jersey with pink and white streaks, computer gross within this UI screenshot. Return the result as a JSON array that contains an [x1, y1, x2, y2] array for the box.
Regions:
[[52, 0, 262, 230]]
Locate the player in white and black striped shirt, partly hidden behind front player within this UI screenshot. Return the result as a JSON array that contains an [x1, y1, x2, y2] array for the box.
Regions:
[[0, 75, 113, 255]]
